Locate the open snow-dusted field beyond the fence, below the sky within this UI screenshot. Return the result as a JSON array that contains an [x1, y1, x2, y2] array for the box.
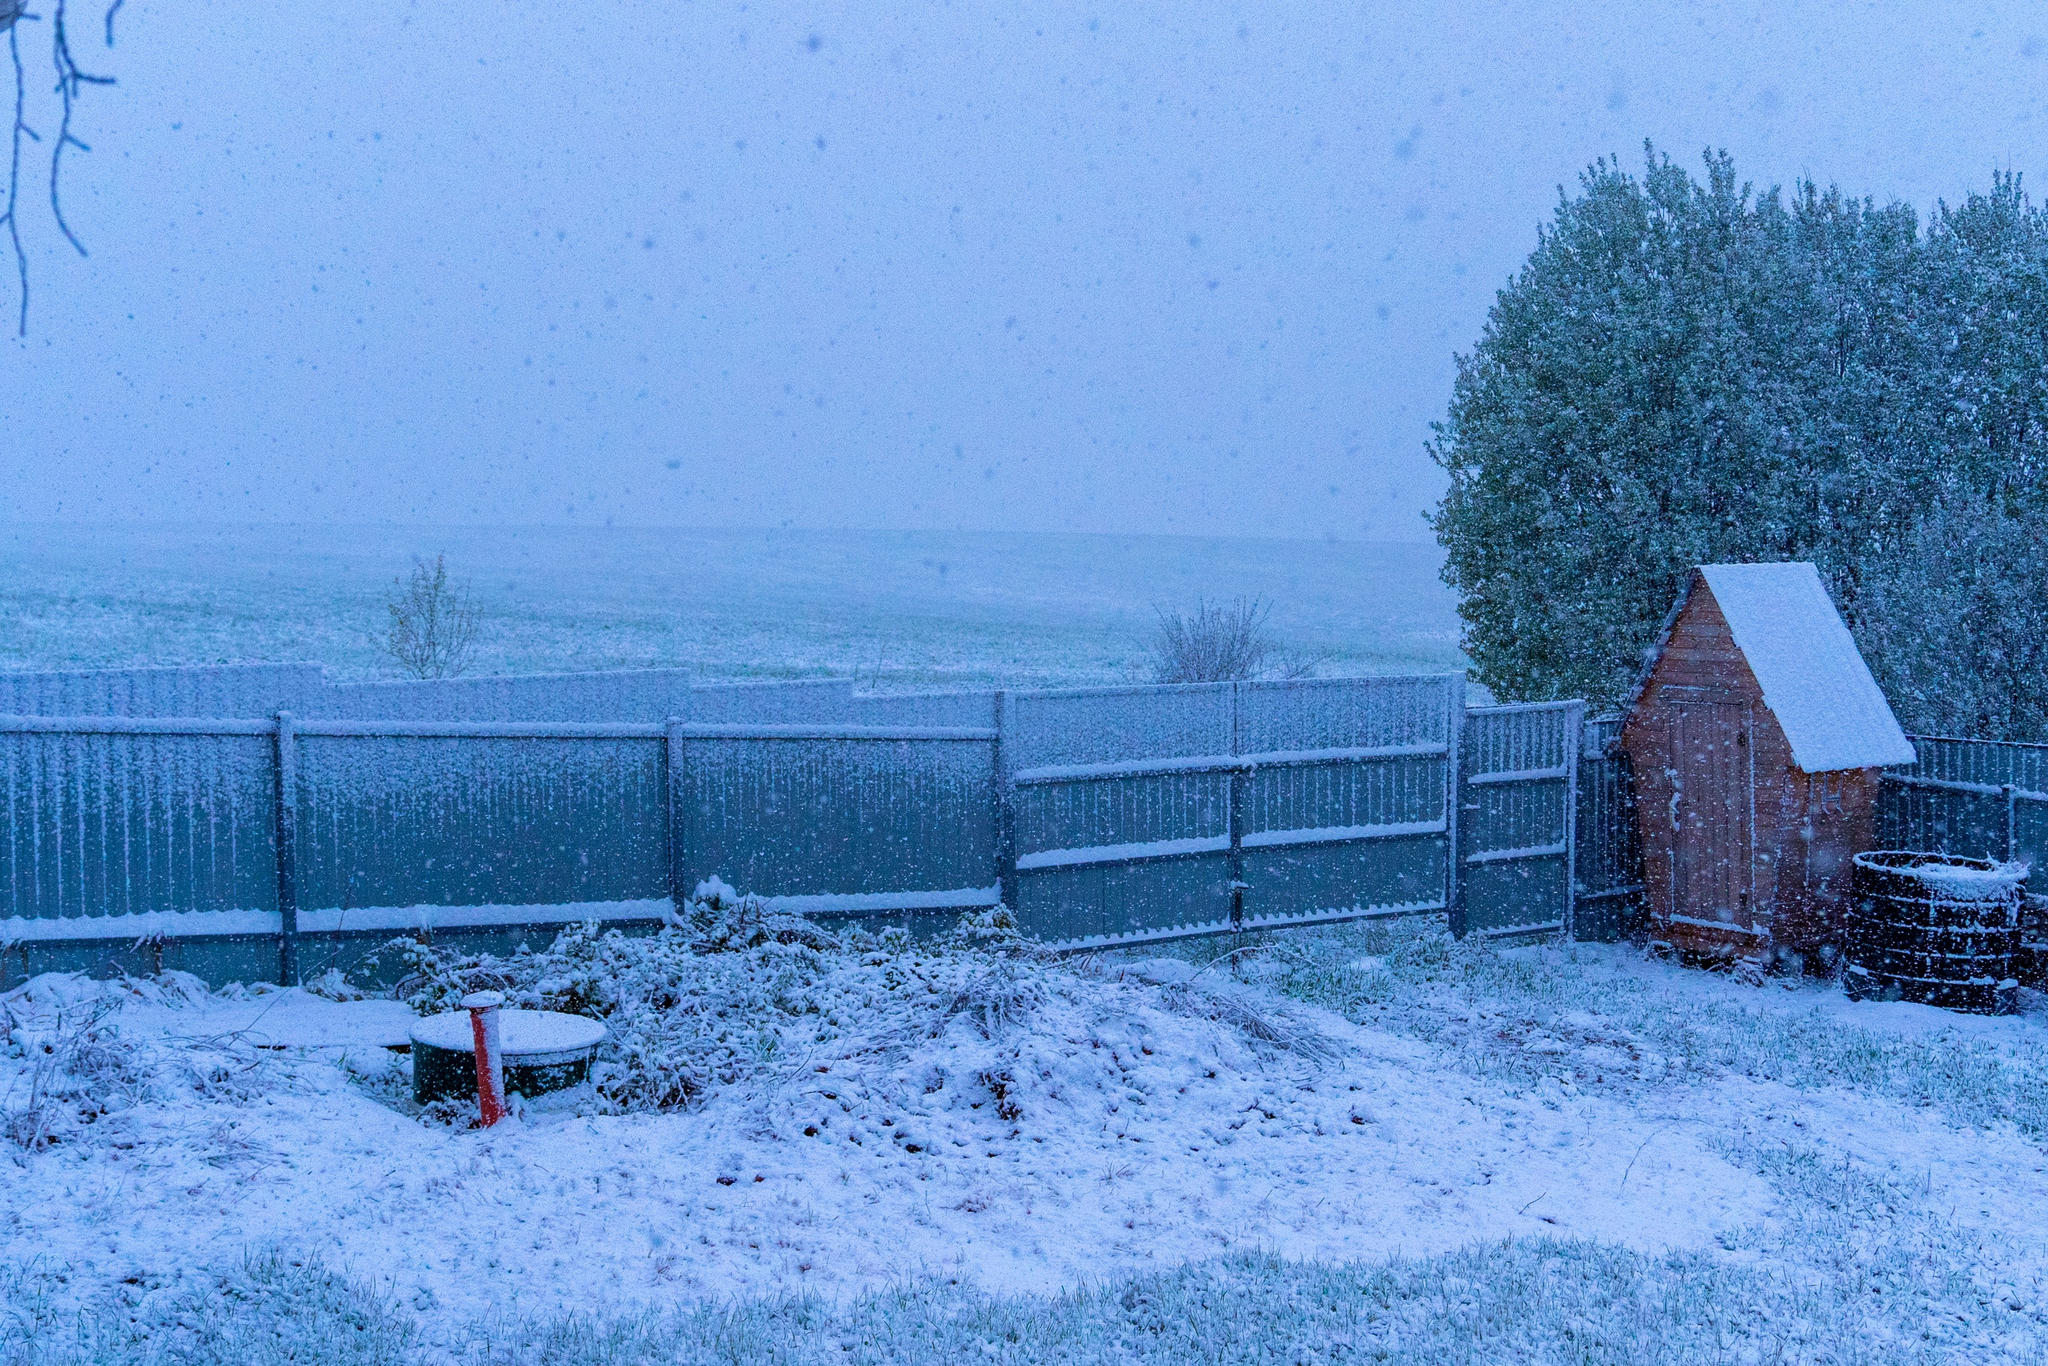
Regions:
[[0, 526, 1462, 688]]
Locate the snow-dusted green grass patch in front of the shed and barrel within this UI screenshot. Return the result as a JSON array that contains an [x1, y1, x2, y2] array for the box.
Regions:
[[1220, 920, 2048, 1137]]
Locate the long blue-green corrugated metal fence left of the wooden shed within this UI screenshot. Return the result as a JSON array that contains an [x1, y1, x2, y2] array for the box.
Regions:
[[0, 670, 1638, 981]]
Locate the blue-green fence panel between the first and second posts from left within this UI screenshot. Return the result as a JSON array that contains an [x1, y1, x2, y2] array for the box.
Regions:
[[297, 723, 668, 913]]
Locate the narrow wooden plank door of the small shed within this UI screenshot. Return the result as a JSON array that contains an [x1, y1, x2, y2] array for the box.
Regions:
[[1671, 698, 1755, 930]]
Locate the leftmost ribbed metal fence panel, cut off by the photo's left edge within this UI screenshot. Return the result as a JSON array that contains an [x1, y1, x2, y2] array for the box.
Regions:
[[0, 727, 276, 940]]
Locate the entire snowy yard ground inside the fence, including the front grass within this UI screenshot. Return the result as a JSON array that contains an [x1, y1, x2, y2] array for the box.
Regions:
[[0, 924, 2048, 1366]]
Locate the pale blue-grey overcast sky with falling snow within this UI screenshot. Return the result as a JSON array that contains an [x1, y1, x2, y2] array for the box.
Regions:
[[0, 0, 2048, 539]]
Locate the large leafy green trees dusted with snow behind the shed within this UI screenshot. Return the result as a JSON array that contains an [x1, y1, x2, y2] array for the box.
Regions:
[[1430, 150, 2048, 737]]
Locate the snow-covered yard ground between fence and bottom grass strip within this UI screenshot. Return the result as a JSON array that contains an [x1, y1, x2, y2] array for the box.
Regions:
[[12, 909, 2048, 1360]]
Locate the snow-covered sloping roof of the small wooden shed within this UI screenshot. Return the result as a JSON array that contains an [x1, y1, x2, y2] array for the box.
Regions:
[[1649, 561, 1915, 772]]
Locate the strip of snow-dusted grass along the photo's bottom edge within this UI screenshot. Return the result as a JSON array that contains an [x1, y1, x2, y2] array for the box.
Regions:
[[0, 1212, 2048, 1366]]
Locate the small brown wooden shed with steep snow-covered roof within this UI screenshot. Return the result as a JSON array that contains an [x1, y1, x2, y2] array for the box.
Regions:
[[1622, 563, 1913, 967]]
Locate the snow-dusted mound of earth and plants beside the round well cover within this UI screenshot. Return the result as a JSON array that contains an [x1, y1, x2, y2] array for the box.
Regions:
[[382, 883, 1354, 1155]]
